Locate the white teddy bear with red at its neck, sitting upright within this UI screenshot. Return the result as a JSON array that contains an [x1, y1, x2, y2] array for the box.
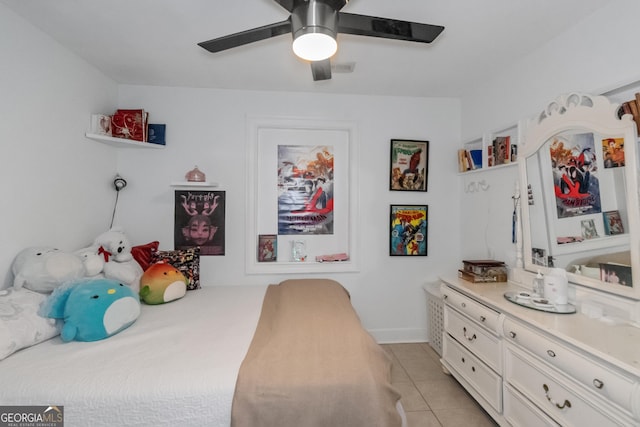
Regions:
[[93, 228, 144, 294]]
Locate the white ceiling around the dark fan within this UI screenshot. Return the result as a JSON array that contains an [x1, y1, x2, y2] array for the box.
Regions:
[[0, 0, 613, 96]]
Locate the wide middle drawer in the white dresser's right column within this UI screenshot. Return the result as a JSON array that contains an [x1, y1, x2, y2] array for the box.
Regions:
[[504, 344, 632, 427]]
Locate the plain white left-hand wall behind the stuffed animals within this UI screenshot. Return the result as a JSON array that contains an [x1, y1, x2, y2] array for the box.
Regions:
[[0, 5, 117, 288]]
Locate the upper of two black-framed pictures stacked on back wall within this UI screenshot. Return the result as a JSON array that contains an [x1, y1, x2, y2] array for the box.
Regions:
[[389, 139, 429, 191]]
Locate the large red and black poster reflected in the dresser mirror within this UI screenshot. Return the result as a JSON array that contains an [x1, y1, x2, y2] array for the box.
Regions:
[[549, 133, 601, 218]]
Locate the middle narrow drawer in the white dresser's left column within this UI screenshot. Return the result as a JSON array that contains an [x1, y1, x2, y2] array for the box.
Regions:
[[444, 307, 502, 372]]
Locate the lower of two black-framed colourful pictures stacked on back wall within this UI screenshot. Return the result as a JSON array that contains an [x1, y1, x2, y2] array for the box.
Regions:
[[389, 205, 429, 256]]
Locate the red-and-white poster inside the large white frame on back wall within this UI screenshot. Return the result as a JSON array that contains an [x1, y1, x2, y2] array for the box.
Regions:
[[278, 145, 334, 235]]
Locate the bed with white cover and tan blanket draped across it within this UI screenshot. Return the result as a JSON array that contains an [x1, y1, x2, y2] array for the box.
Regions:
[[0, 279, 405, 427]]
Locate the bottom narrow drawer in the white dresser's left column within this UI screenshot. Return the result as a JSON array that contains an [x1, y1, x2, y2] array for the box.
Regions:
[[443, 333, 502, 413]]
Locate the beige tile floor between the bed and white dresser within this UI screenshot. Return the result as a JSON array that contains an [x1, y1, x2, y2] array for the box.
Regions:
[[382, 343, 497, 427]]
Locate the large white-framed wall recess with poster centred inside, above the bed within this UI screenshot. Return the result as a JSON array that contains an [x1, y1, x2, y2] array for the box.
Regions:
[[245, 117, 359, 274]]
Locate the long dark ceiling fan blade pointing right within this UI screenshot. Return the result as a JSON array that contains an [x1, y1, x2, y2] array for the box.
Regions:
[[338, 12, 444, 43]]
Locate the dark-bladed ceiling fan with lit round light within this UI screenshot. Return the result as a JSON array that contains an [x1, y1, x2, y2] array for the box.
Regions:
[[198, 0, 444, 80]]
